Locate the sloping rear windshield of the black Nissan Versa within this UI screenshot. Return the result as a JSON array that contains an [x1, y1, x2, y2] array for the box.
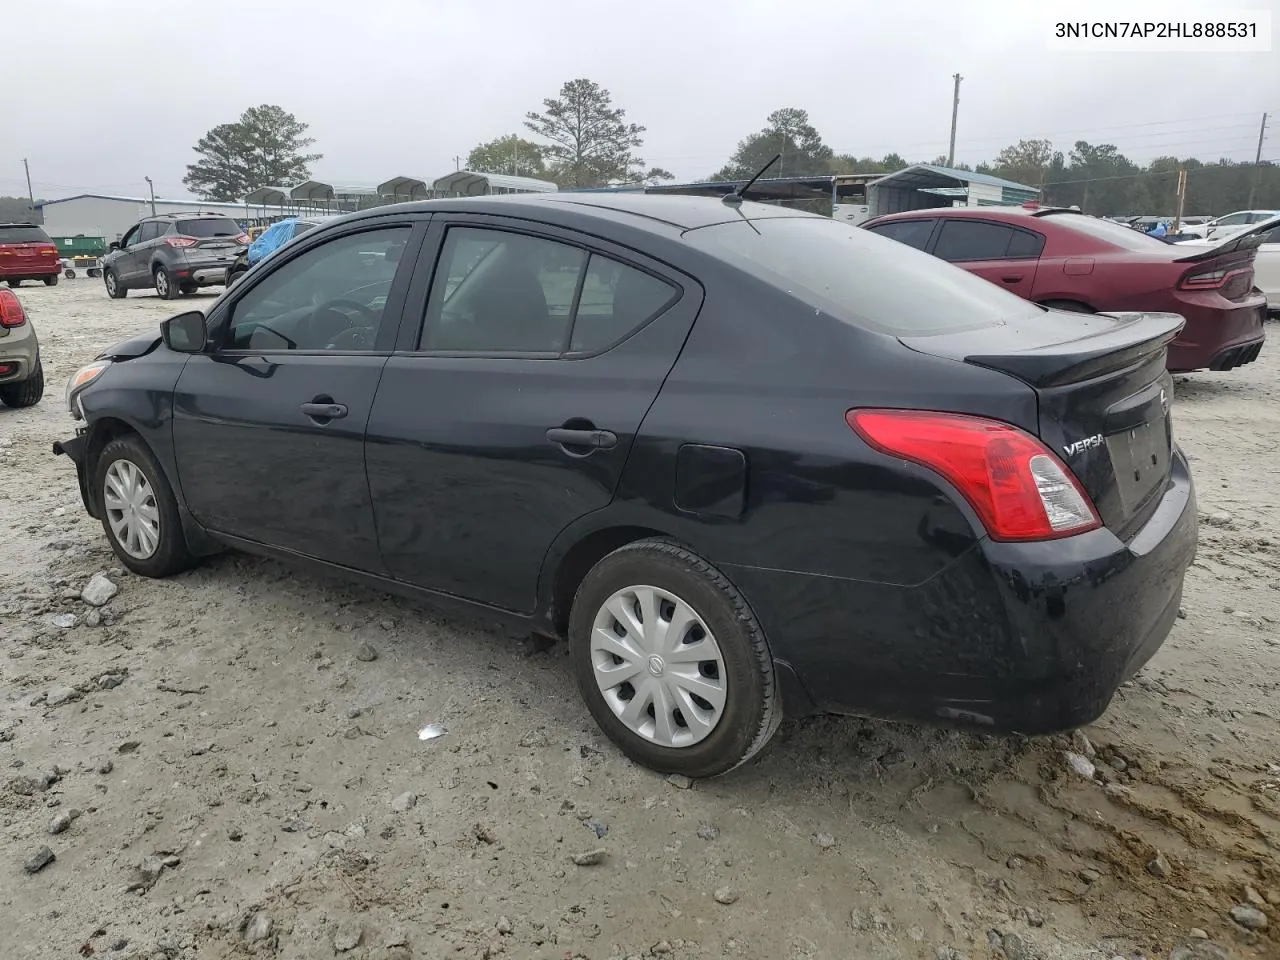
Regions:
[[685, 216, 1044, 337]]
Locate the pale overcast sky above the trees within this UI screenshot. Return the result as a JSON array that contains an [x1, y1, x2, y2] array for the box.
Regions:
[[0, 0, 1280, 197]]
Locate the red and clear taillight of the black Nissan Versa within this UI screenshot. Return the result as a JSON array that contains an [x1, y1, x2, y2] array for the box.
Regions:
[[845, 410, 1102, 540]]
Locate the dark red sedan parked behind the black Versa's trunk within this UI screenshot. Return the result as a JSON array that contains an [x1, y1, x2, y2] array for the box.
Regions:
[[863, 204, 1267, 372]]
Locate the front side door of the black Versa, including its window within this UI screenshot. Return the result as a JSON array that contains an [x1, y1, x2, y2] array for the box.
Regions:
[[173, 220, 425, 573]]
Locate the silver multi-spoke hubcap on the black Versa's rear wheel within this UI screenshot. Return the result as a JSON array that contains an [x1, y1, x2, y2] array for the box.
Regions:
[[591, 586, 728, 748]]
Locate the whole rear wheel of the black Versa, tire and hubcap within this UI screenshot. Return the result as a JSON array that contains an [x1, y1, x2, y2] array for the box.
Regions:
[[568, 540, 782, 777]]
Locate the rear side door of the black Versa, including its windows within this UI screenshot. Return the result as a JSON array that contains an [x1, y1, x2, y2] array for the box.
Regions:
[[365, 216, 703, 612]]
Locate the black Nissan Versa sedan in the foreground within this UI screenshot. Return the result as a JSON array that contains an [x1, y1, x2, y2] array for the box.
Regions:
[[54, 193, 1197, 776]]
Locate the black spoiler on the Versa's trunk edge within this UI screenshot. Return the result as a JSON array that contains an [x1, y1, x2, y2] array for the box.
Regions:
[[965, 312, 1187, 387]]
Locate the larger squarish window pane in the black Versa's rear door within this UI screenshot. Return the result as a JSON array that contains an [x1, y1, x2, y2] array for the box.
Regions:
[[421, 227, 586, 353]]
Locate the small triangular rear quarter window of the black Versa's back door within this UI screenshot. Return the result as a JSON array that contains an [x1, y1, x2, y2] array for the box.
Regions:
[[568, 253, 677, 353]]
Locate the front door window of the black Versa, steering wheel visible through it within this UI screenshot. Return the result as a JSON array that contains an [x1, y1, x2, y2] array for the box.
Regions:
[[227, 227, 410, 351]]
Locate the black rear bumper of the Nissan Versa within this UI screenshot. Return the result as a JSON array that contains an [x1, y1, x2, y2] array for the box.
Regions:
[[724, 452, 1197, 733]]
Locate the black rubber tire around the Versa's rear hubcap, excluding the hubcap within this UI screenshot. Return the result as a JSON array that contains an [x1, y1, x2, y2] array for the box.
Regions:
[[568, 539, 782, 777]]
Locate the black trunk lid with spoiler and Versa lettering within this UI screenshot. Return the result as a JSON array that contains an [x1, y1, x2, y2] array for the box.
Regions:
[[900, 311, 1185, 539]]
